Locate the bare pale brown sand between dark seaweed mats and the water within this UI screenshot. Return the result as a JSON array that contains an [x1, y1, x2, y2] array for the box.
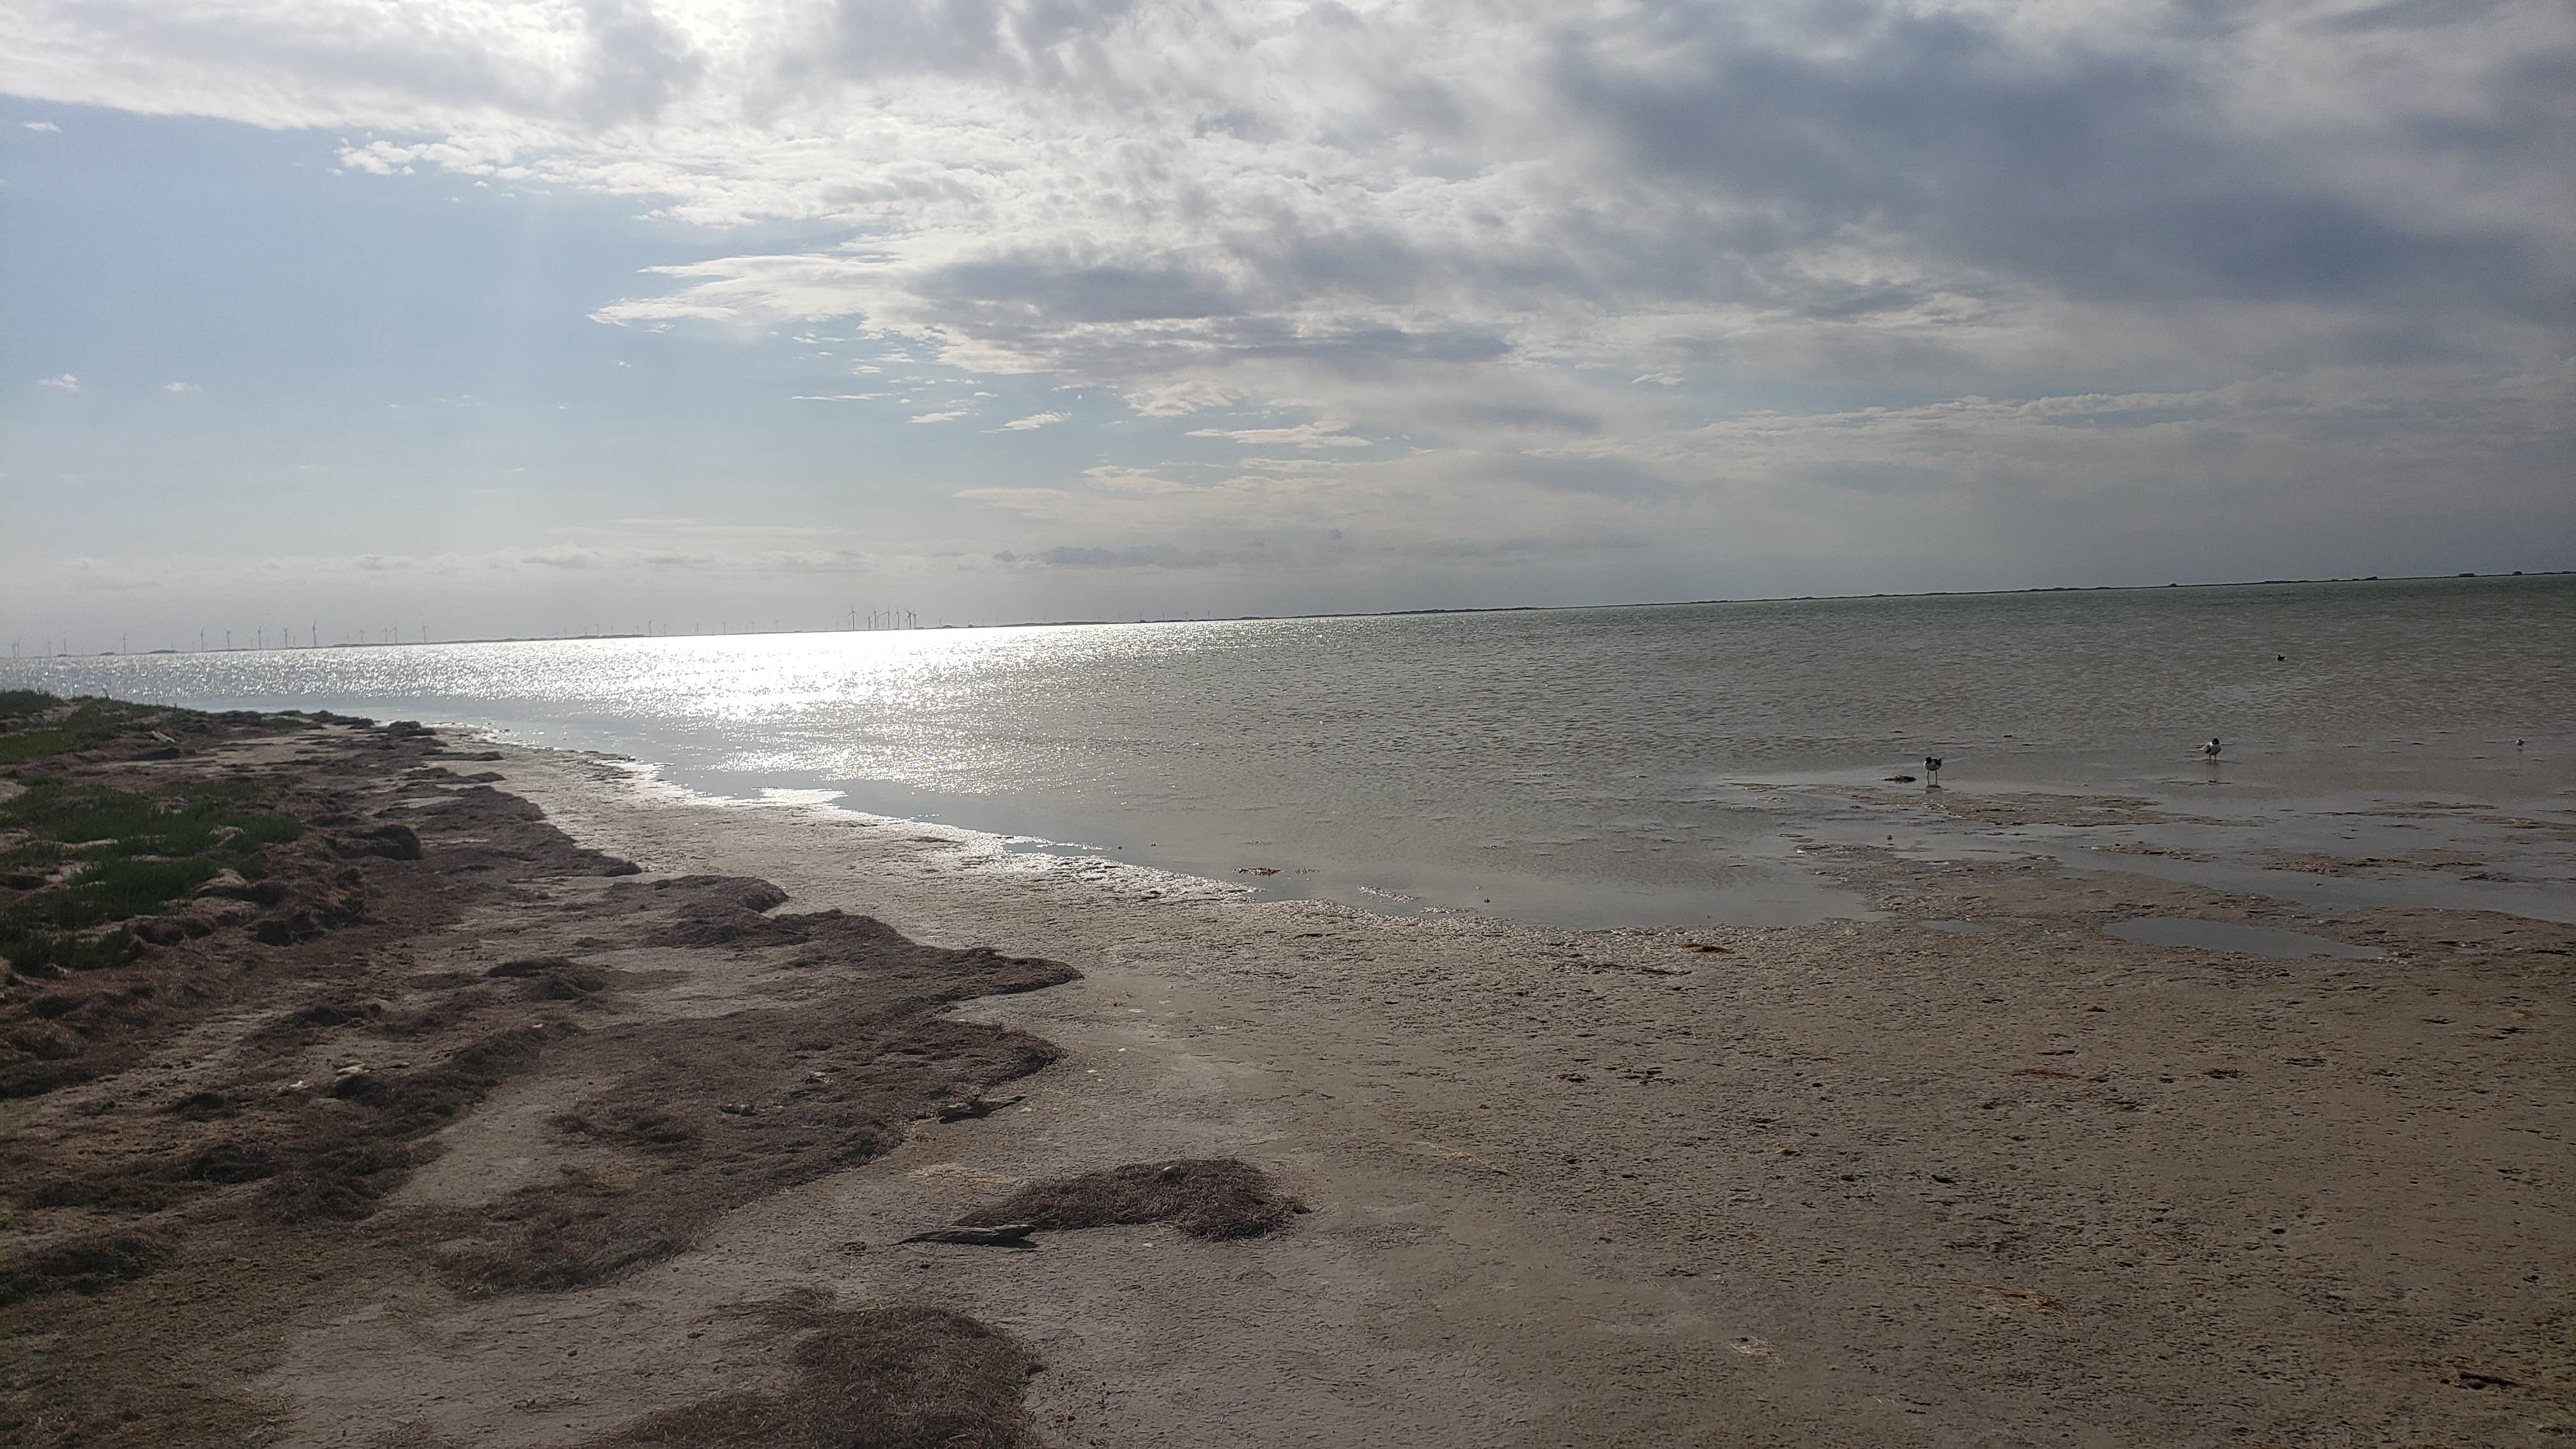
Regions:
[[0, 711, 2576, 1446]]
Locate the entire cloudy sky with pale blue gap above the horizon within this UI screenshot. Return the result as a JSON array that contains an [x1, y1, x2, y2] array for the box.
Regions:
[[0, 0, 2576, 641]]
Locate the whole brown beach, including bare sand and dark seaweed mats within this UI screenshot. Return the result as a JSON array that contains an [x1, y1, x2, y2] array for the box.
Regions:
[[0, 696, 2576, 1446]]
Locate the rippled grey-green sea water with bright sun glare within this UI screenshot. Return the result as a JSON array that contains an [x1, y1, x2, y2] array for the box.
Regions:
[[0, 578, 2576, 926]]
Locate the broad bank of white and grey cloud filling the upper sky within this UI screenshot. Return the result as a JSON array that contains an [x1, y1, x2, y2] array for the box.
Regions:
[[0, 0, 2576, 588]]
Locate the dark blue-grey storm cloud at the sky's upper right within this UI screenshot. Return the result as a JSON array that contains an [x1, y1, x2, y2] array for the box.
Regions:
[[1553, 8, 2566, 309]]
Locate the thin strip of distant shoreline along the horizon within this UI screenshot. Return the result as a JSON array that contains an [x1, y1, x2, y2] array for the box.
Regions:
[[8, 570, 2576, 665]]
